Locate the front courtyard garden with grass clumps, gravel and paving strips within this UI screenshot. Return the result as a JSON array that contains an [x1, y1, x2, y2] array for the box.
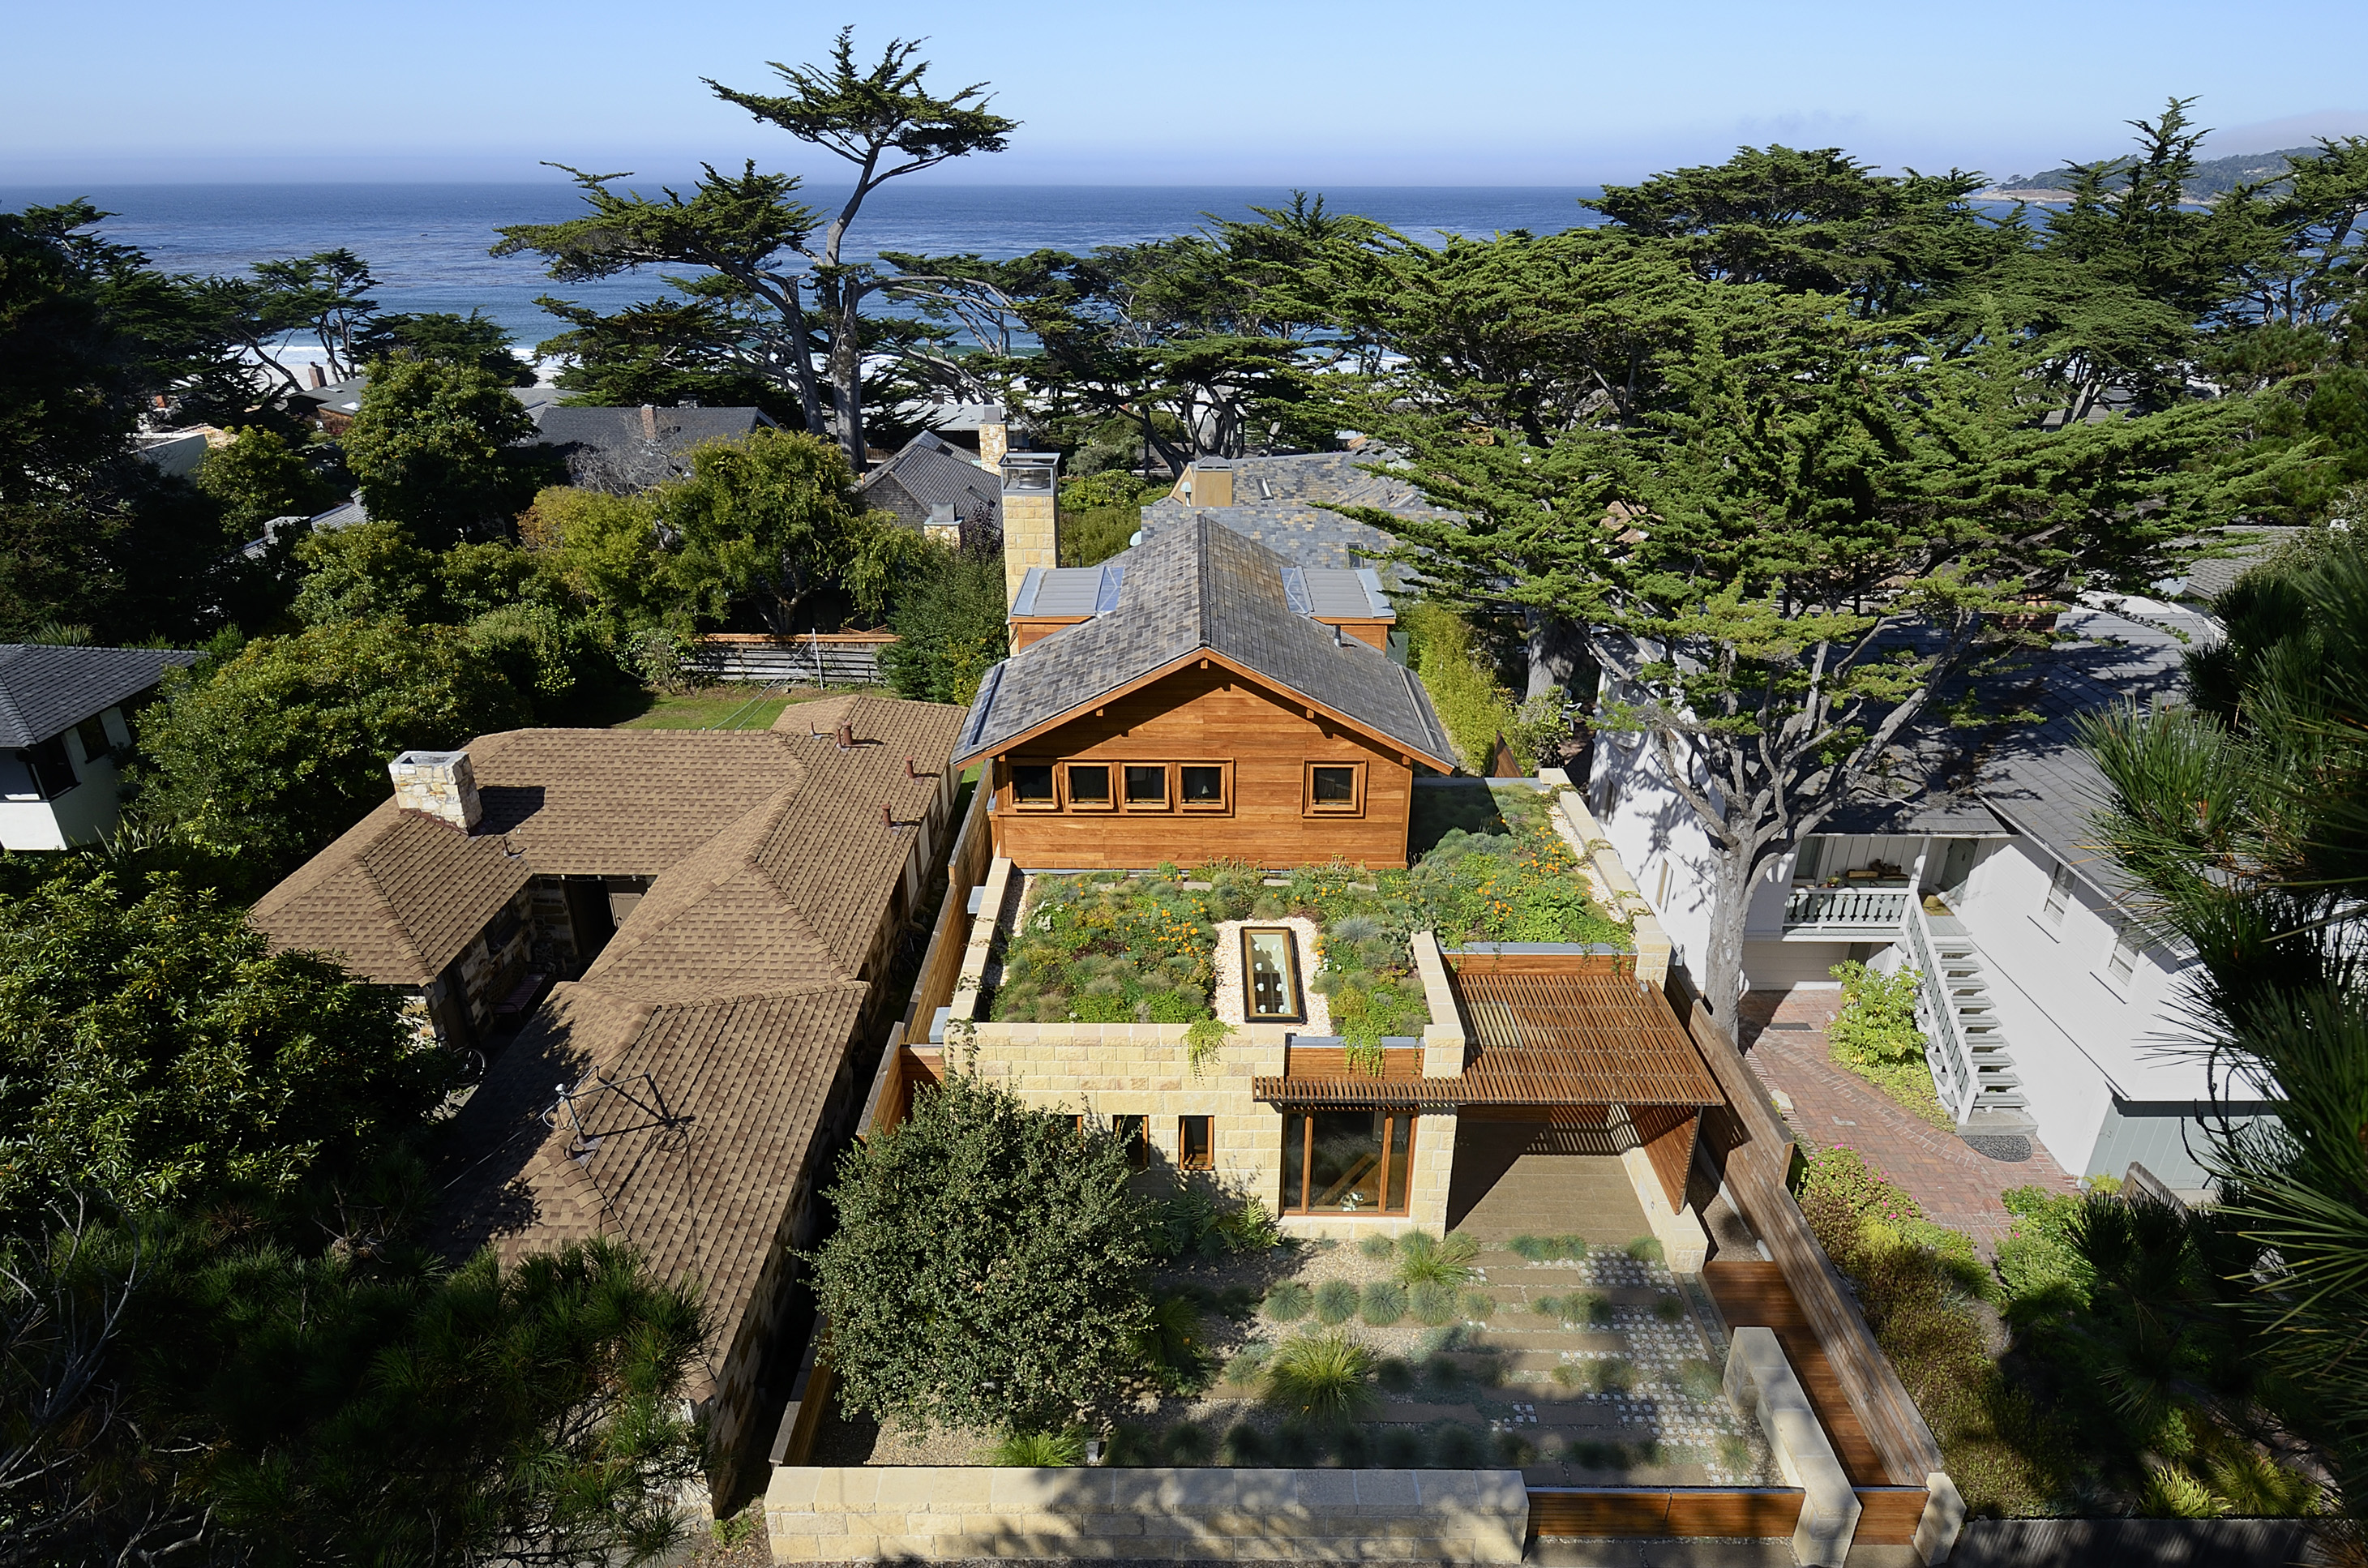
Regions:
[[812, 1236, 1776, 1485]]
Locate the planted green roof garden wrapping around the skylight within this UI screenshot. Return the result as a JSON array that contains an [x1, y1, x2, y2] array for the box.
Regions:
[[992, 786, 1634, 1047]]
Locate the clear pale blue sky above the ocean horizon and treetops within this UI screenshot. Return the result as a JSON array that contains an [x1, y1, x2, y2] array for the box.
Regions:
[[0, 0, 2368, 185]]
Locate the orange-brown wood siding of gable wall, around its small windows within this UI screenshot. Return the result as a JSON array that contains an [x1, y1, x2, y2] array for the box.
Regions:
[[990, 663, 1414, 869]]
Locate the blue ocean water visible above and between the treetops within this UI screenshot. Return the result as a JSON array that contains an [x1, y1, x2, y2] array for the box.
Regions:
[[0, 182, 1599, 348]]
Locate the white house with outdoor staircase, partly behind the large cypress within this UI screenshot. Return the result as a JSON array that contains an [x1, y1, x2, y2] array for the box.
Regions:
[[1589, 599, 2266, 1191]]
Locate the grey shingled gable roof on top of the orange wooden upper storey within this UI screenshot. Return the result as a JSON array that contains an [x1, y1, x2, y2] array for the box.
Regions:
[[954, 519, 1454, 769]]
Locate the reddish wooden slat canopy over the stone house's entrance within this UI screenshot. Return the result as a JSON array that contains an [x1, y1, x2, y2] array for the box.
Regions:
[[1253, 966, 1726, 1108]]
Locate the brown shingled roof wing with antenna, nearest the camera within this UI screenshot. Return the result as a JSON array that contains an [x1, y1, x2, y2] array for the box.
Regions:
[[440, 980, 869, 1392]]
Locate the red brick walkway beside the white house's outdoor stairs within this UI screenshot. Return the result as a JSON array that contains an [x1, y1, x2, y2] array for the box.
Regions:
[[1738, 990, 2077, 1255]]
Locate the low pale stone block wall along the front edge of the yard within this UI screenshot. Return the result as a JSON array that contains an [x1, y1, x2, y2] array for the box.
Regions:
[[764, 1466, 1530, 1563]]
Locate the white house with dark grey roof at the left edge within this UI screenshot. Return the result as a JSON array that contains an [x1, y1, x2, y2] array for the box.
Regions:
[[0, 642, 196, 850]]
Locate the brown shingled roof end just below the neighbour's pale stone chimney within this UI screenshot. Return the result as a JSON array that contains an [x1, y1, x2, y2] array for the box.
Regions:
[[249, 800, 528, 985]]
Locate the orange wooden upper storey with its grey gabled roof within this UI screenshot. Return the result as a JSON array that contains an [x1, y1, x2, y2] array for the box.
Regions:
[[954, 519, 1456, 869]]
